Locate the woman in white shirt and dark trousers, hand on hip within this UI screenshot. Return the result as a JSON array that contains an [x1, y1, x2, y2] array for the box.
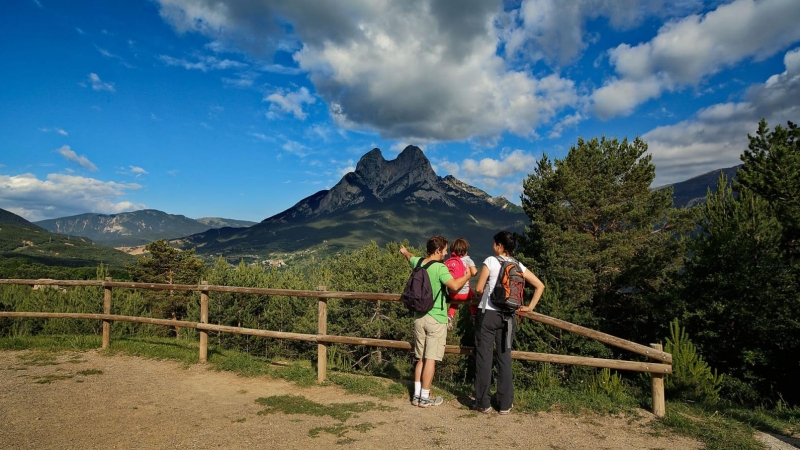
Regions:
[[473, 231, 544, 415]]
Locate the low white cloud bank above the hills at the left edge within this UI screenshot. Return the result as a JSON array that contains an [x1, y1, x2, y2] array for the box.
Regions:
[[0, 173, 145, 221]]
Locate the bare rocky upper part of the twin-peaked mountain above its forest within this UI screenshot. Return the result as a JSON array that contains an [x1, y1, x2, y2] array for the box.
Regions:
[[262, 145, 520, 223]]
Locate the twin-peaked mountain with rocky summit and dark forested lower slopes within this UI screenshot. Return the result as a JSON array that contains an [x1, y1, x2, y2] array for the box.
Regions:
[[176, 146, 527, 255]]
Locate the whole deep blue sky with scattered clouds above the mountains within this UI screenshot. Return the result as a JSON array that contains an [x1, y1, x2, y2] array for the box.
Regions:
[[0, 0, 800, 221]]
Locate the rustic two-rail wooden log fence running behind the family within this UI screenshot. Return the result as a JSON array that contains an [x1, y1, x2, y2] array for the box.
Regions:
[[0, 278, 672, 417]]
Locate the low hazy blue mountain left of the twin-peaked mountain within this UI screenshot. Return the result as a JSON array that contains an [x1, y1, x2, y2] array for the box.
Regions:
[[36, 209, 254, 247]]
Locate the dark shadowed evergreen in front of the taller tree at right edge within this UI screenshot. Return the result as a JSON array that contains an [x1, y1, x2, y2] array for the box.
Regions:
[[682, 176, 800, 401]]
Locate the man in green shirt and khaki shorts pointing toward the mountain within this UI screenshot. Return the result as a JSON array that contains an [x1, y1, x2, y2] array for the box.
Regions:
[[400, 235, 470, 408]]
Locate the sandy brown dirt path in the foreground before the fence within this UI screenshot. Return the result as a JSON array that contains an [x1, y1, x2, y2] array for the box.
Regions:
[[0, 351, 702, 450]]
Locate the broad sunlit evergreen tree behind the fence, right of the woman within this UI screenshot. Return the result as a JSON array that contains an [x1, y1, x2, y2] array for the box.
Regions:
[[522, 138, 691, 348]]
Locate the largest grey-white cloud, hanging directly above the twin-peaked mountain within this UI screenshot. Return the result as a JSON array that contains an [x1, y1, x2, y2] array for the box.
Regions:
[[153, 0, 579, 142]]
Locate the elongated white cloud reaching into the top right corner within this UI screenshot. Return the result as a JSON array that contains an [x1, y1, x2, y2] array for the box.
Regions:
[[592, 0, 800, 118]]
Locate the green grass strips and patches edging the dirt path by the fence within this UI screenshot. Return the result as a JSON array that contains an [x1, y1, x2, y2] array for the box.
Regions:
[[0, 336, 800, 449]]
